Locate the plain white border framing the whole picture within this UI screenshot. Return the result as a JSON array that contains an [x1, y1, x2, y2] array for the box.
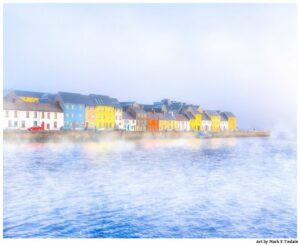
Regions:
[[0, 0, 300, 245]]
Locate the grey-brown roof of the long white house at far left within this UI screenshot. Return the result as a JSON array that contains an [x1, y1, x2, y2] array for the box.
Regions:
[[3, 101, 63, 112]]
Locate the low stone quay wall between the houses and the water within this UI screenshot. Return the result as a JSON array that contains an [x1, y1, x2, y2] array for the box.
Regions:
[[3, 130, 271, 142]]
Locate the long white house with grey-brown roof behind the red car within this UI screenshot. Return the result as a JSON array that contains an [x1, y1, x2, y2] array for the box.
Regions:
[[3, 101, 64, 130]]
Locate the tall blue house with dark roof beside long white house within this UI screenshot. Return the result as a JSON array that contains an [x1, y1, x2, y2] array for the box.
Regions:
[[55, 92, 89, 129]]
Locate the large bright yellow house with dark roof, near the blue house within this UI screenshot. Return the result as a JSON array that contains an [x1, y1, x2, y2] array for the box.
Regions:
[[89, 94, 115, 129]]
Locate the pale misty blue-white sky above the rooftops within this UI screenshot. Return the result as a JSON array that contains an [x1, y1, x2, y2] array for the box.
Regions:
[[3, 4, 297, 129]]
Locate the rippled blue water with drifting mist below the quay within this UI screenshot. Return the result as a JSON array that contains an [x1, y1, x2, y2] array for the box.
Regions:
[[3, 138, 297, 238]]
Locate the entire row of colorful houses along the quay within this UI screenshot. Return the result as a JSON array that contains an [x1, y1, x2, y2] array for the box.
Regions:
[[3, 90, 237, 132]]
